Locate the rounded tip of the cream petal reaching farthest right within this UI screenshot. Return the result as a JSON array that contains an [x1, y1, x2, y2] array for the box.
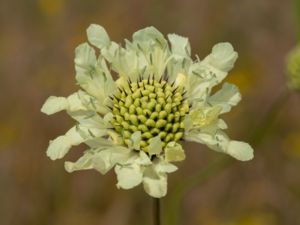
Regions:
[[227, 141, 254, 161]]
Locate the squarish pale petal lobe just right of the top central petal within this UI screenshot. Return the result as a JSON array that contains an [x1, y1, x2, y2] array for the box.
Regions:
[[168, 34, 191, 59]]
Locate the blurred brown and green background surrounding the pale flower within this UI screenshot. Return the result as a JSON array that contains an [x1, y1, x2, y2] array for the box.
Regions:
[[0, 0, 300, 225]]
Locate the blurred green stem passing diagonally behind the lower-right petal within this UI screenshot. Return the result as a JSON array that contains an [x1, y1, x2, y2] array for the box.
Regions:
[[166, 89, 290, 225]]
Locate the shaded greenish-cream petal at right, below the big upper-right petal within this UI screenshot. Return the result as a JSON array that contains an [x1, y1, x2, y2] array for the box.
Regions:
[[208, 83, 242, 113]]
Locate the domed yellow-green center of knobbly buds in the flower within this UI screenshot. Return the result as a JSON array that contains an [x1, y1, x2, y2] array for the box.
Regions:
[[111, 76, 189, 152]]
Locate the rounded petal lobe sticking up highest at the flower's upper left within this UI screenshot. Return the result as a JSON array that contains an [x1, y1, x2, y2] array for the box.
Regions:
[[87, 24, 110, 49]]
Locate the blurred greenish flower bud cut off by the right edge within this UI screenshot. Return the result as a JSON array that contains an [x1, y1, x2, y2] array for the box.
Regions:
[[287, 46, 300, 91]]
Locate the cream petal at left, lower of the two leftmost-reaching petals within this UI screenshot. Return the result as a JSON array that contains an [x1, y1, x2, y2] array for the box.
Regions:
[[47, 127, 84, 160]]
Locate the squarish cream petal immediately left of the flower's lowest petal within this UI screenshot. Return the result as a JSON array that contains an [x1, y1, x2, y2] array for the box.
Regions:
[[115, 164, 143, 189]]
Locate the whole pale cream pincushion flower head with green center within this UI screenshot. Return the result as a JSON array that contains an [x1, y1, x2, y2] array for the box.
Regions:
[[42, 24, 253, 198]]
